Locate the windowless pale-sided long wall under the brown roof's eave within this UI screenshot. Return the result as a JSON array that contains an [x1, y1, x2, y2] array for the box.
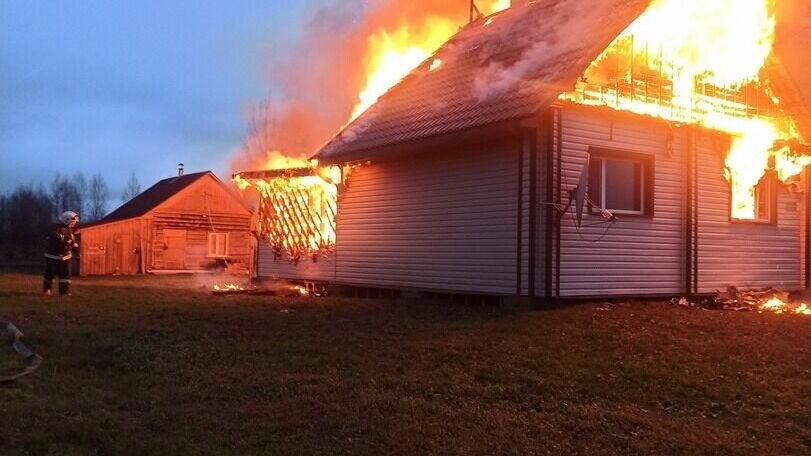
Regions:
[[335, 141, 526, 295]]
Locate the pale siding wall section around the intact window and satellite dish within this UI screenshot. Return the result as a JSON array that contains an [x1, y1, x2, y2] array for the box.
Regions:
[[555, 107, 685, 297]]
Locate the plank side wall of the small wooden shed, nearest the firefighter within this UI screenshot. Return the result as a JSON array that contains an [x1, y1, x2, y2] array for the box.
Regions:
[[79, 219, 146, 275]]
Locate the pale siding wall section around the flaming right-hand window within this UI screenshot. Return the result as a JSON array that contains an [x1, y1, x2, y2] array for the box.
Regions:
[[696, 132, 804, 293]]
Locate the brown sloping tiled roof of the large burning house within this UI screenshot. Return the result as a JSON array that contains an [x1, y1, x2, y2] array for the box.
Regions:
[[315, 0, 649, 162]]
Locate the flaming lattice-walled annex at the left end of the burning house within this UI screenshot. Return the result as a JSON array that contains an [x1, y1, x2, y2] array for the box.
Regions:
[[234, 167, 341, 262]]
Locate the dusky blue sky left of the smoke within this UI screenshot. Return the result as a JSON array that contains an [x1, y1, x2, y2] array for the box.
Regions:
[[0, 0, 329, 201]]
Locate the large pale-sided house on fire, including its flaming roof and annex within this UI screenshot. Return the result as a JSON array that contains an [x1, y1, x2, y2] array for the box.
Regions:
[[236, 0, 811, 298]]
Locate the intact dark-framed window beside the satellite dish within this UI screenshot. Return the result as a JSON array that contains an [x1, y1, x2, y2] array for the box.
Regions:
[[588, 150, 653, 215]]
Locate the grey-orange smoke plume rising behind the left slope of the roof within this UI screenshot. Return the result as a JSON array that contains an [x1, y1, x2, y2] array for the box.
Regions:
[[231, 0, 495, 172]]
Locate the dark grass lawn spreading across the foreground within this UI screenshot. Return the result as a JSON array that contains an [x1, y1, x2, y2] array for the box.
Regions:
[[0, 273, 811, 455]]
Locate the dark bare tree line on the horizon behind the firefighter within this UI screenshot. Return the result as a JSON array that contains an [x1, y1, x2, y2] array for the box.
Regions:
[[0, 173, 141, 259]]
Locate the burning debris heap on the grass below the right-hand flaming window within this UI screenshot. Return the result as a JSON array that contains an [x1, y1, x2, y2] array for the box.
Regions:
[[671, 287, 811, 315]]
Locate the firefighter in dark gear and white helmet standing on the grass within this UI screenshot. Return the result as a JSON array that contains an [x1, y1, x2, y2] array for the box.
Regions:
[[42, 211, 79, 295]]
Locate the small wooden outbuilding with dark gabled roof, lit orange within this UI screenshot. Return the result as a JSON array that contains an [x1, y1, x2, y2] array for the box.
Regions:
[[78, 171, 256, 275]]
